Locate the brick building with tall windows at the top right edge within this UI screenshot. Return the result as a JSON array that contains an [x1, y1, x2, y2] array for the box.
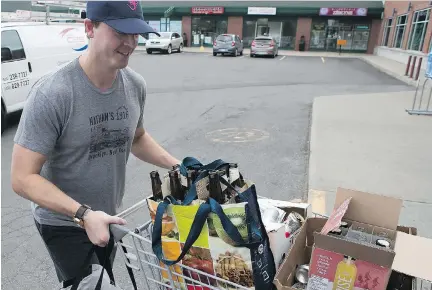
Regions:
[[376, 1, 432, 63]]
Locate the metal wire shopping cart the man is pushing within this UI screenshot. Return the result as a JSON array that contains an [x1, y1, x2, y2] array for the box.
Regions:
[[110, 199, 250, 290]]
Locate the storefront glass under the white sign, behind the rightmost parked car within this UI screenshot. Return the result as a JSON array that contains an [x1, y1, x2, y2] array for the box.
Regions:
[[243, 17, 297, 49]]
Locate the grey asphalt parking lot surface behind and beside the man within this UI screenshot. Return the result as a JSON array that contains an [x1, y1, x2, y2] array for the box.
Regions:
[[1, 51, 408, 290]]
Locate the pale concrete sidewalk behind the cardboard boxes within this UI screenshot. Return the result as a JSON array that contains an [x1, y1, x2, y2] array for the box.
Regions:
[[309, 91, 432, 238]]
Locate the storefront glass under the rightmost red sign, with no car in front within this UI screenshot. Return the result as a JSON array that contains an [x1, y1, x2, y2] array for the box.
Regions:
[[310, 18, 370, 51]]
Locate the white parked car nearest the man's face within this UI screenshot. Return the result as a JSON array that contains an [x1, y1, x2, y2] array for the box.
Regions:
[[146, 32, 183, 54]]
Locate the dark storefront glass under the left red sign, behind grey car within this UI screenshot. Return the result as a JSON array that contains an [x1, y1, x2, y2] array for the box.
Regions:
[[192, 16, 228, 46]]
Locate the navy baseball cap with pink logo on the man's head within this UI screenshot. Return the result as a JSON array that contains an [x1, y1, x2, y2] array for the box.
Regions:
[[86, 0, 159, 35]]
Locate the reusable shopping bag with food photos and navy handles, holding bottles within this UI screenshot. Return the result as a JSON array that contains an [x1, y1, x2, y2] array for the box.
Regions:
[[147, 157, 276, 290]]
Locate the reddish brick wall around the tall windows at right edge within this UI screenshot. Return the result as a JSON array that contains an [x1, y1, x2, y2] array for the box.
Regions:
[[376, 1, 432, 53]]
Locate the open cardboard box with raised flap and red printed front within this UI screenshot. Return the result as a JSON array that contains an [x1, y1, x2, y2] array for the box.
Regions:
[[307, 188, 402, 290]]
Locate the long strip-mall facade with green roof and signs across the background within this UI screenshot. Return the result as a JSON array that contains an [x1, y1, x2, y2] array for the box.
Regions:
[[142, 1, 384, 53]]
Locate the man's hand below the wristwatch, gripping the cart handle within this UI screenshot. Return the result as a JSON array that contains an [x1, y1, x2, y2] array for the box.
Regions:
[[84, 210, 126, 247]]
